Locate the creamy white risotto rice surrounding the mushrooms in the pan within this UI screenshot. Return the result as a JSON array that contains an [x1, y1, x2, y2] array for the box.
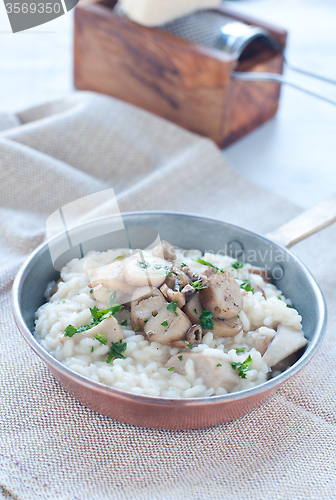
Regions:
[[36, 250, 301, 398]]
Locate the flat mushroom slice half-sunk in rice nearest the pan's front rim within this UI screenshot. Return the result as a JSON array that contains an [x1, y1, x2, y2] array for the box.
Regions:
[[166, 352, 239, 392]]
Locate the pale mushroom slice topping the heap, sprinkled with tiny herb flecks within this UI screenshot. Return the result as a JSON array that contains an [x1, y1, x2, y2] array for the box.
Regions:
[[124, 255, 172, 287]]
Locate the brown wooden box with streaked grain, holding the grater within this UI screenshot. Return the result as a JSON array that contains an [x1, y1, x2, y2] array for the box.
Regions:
[[74, 0, 287, 147]]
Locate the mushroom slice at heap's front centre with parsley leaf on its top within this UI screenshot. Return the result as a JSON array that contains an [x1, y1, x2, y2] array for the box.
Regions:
[[144, 304, 191, 344]]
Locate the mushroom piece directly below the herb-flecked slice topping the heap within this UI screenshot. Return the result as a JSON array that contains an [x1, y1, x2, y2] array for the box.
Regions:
[[131, 287, 167, 331]]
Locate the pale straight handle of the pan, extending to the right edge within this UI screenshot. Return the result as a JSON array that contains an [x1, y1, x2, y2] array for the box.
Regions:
[[266, 195, 336, 248]]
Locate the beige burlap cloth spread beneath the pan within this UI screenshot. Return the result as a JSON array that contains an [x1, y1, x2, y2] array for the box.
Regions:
[[0, 93, 336, 500]]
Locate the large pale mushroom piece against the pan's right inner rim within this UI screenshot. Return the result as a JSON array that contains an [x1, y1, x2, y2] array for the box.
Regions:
[[263, 325, 307, 367]]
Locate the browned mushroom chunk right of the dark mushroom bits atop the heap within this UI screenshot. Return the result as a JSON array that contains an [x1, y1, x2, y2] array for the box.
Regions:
[[199, 273, 243, 319]]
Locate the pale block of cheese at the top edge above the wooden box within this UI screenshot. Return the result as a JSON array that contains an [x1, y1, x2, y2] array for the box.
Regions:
[[119, 0, 221, 27]]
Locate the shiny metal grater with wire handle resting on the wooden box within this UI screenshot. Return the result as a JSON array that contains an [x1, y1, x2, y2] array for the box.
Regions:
[[114, 3, 336, 105]]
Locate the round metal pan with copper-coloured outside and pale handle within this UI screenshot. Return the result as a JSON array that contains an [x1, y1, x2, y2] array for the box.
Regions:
[[12, 198, 336, 429]]
